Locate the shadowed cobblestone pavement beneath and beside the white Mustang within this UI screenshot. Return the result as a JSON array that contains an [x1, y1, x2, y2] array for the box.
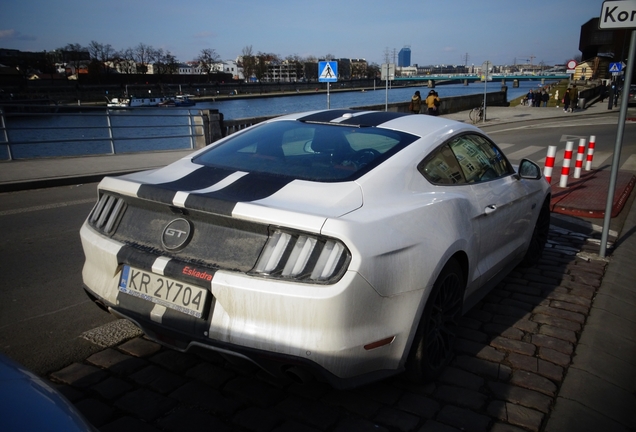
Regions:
[[49, 226, 606, 432]]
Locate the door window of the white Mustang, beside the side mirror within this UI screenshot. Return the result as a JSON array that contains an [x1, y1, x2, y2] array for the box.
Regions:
[[448, 135, 512, 183]]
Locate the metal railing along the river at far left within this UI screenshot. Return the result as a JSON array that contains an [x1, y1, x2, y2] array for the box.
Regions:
[[0, 106, 205, 161]]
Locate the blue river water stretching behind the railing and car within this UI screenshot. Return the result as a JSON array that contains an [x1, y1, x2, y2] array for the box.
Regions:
[[0, 80, 556, 160]]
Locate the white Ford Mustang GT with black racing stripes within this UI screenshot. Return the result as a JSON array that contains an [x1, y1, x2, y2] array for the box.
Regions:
[[81, 110, 550, 388]]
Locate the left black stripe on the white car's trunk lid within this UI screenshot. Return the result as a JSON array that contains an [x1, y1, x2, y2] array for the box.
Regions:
[[137, 166, 235, 204]]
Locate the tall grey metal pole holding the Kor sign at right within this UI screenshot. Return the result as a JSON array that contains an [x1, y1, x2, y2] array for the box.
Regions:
[[599, 30, 636, 258]]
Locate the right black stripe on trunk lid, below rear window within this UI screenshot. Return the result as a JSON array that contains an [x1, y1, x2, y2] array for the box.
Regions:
[[185, 173, 294, 216]]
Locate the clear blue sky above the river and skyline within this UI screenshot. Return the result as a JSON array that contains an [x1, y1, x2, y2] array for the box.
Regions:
[[0, 0, 602, 65]]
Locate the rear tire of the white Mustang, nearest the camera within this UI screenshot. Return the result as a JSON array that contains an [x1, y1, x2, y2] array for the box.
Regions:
[[406, 259, 465, 382]]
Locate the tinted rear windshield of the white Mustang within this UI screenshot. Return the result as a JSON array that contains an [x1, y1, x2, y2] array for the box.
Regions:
[[194, 120, 417, 182]]
